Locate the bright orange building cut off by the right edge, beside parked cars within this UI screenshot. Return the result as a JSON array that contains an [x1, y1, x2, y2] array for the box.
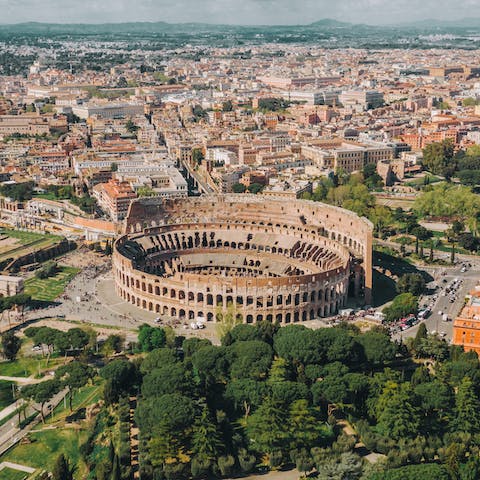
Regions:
[[453, 287, 480, 356]]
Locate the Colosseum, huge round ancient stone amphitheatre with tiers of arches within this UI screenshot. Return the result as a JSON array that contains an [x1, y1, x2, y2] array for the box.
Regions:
[[113, 194, 372, 324]]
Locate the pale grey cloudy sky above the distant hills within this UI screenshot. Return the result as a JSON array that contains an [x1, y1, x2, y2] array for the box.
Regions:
[[0, 0, 480, 25]]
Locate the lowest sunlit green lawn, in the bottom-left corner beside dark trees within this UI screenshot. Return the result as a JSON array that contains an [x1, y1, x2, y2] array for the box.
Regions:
[[0, 428, 87, 474]]
